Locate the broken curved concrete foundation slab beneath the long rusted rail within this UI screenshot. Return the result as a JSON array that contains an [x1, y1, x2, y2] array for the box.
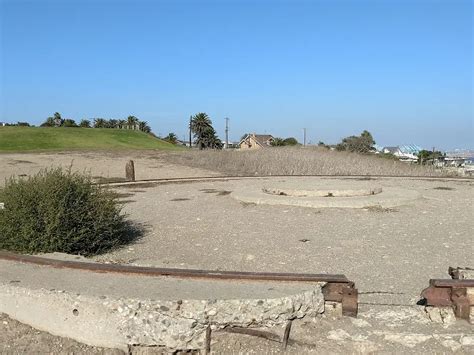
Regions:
[[0, 260, 324, 349]]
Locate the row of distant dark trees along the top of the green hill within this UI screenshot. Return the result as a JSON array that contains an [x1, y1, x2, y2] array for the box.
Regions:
[[41, 112, 151, 133]]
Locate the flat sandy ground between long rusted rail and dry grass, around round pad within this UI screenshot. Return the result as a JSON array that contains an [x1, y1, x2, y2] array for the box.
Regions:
[[97, 178, 474, 305]]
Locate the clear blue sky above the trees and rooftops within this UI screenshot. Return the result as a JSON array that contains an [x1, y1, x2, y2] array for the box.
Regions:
[[0, 0, 474, 149]]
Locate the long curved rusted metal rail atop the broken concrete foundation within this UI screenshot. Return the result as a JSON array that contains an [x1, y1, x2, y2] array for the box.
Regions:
[[0, 250, 358, 317]]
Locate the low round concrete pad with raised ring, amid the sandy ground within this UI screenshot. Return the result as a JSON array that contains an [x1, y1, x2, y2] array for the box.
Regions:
[[232, 177, 420, 208]]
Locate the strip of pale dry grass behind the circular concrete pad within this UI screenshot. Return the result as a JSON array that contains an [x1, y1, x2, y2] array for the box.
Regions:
[[165, 148, 445, 176]]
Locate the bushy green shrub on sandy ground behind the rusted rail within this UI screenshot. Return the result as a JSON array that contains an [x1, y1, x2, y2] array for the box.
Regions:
[[0, 168, 140, 255]]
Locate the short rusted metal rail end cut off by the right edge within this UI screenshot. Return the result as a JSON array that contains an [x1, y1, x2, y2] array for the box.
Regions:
[[421, 279, 474, 320]]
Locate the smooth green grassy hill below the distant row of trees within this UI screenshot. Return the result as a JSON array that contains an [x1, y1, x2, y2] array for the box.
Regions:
[[0, 127, 179, 152]]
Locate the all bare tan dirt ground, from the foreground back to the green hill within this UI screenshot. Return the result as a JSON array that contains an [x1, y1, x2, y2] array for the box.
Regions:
[[0, 152, 474, 354]]
